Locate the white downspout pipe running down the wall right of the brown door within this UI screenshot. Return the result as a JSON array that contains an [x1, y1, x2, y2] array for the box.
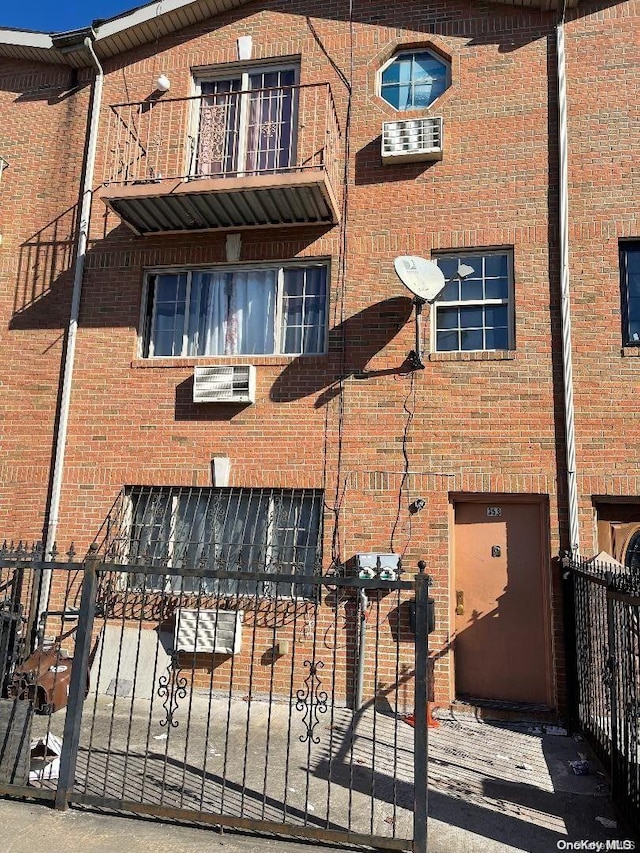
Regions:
[[556, 21, 580, 553]]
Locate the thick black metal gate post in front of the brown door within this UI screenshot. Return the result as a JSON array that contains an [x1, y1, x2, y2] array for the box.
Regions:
[[413, 560, 429, 853]]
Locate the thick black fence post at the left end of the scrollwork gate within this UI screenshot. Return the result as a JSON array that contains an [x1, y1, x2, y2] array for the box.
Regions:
[[55, 545, 100, 810]]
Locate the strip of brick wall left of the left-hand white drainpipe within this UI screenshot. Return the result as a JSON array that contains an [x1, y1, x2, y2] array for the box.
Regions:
[[0, 59, 89, 538]]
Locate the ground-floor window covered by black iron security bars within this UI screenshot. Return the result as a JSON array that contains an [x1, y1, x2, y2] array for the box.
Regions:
[[121, 486, 322, 597]]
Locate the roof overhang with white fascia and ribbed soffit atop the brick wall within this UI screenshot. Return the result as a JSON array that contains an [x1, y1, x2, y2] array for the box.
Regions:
[[0, 0, 580, 68]]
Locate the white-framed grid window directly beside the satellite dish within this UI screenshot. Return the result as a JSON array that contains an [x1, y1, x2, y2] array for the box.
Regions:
[[431, 250, 514, 352]]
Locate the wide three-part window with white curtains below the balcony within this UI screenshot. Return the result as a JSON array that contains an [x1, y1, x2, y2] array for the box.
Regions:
[[143, 264, 327, 358]]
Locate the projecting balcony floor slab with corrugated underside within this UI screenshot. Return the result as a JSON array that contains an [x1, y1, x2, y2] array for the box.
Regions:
[[100, 169, 339, 235]]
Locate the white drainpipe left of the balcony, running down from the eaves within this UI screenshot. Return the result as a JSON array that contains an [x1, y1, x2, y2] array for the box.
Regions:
[[38, 36, 104, 619]]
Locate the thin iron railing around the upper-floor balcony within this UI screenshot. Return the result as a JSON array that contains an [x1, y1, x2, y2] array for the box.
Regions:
[[103, 83, 341, 198]]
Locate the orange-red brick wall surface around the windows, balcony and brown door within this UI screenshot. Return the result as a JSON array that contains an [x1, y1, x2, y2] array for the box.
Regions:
[[0, 0, 640, 701]]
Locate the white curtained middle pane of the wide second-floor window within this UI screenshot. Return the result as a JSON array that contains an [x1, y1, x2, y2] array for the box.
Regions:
[[189, 270, 276, 355]]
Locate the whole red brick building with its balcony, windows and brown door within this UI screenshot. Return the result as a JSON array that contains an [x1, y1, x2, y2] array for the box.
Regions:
[[0, 0, 640, 709]]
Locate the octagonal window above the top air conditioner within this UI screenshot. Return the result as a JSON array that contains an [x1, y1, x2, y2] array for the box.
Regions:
[[380, 50, 450, 110]]
